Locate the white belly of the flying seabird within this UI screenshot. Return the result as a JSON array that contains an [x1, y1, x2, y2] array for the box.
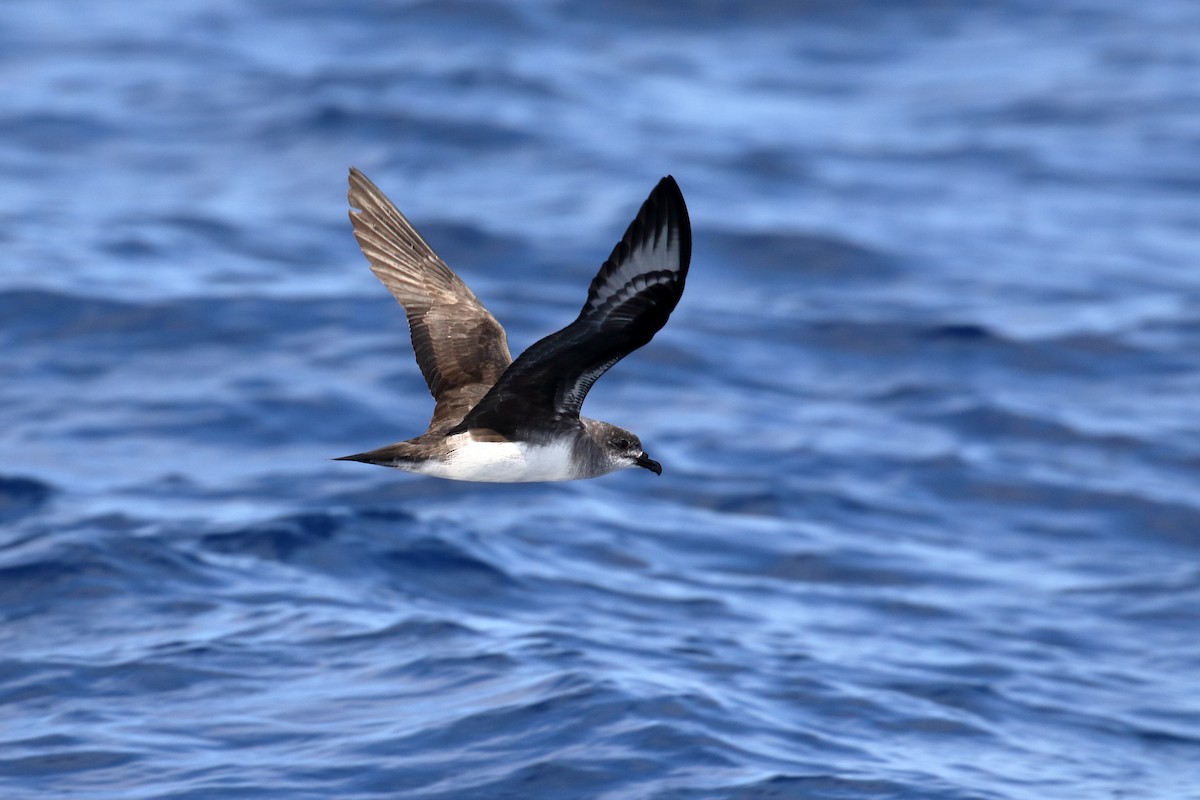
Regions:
[[413, 433, 576, 483]]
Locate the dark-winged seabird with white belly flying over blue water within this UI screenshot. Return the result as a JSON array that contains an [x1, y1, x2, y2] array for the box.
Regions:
[[337, 168, 691, 483]]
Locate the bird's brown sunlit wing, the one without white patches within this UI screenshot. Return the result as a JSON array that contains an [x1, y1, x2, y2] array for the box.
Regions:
[[348, 168, 512, 432]]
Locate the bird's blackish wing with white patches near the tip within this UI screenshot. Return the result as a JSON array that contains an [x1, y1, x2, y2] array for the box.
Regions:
[[455, 175, 691, 435]]
